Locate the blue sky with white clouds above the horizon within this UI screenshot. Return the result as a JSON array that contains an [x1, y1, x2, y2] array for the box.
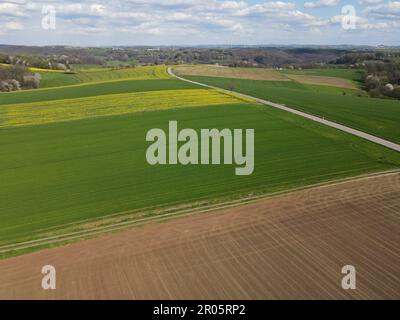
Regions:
[[0, 0, 400, 46]]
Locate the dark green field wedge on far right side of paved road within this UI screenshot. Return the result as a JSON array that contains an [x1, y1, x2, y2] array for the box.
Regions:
[[186, 76, 400, 143]]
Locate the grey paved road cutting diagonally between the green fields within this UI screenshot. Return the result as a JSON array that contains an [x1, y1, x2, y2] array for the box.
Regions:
[[168, 68, 400, 152]]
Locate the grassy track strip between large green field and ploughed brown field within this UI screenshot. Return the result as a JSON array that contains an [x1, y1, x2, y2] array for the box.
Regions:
[[0, 169, 400, 260]]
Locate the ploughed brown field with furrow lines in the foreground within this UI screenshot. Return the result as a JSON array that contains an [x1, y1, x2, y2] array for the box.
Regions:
[[0, 173, 400, 299]]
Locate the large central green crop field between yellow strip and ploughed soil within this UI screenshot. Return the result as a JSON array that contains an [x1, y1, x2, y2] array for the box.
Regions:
[[0, 102, 400, 245]]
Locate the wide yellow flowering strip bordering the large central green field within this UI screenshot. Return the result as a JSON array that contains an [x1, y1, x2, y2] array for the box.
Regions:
[[0, 89, 251, 128]]
